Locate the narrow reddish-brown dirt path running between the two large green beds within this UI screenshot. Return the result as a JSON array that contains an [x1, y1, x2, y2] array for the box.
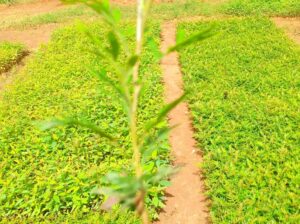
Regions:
[[156, 22, 209, 224]]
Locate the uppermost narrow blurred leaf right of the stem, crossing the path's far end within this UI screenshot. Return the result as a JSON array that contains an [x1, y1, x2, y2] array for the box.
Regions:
[[166, 26, 215, 54]]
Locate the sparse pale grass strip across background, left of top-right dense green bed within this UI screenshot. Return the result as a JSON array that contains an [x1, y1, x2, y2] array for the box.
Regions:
[[0, 0, 216, 30]]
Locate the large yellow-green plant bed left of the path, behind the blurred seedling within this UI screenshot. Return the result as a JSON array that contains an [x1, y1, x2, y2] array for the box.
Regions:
[[0, 21, 168, 223]]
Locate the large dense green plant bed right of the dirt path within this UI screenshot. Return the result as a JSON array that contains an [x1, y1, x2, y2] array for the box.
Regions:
[[179, 18, 300, 224]]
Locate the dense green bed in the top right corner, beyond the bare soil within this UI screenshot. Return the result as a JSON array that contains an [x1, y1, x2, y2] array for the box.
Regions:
[[221, 0, 300, 16]]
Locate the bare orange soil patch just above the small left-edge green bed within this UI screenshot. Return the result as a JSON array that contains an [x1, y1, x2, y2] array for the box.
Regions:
[[0, 24, 58, 51]]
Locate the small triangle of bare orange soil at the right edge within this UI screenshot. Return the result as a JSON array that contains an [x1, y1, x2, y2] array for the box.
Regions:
[[273, 17, 300, 44]]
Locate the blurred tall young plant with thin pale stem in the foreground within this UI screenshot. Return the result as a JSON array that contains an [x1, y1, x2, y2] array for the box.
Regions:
[[42, 0, 212, 224]]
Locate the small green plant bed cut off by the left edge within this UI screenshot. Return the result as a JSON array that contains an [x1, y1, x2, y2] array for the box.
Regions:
[[0, 42, 25, 73]]
